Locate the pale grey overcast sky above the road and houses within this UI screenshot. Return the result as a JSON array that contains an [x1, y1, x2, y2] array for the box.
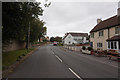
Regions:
[[38, 0, 118, 37]]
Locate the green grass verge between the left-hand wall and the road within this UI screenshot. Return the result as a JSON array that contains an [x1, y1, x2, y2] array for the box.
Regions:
[[2, 48, 34, 67]]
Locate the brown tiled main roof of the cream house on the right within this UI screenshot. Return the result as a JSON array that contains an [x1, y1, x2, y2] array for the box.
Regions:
[[90, 15, 120, 33]]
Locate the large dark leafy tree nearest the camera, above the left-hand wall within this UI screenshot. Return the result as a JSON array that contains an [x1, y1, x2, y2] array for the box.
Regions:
[[2, 2, 43, 42]]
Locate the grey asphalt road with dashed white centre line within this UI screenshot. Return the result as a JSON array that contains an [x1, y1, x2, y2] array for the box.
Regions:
[[8, 45, 118, 79]]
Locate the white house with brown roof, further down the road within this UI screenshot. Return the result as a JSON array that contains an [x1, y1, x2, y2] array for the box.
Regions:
[[63, 32, 89, 45]]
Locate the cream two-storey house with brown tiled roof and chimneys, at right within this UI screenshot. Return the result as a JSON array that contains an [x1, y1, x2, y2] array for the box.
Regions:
[[90, 2, 120, 52]]
